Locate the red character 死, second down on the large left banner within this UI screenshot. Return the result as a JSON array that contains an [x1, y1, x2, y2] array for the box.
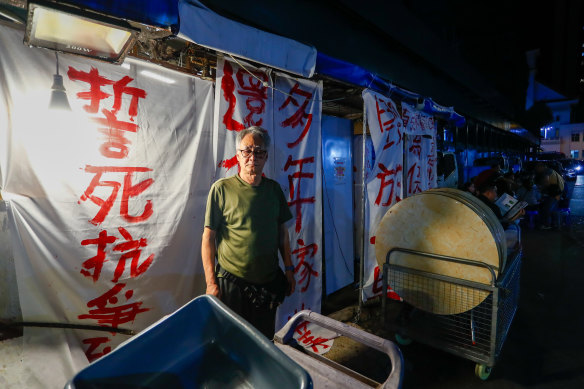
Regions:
[[81, 165, 154, 225]]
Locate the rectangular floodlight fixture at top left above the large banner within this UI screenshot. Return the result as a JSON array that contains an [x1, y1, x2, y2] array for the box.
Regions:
[[24, 1, 137, 63]]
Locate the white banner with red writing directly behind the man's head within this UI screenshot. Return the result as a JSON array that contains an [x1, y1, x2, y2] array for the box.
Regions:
[[213, 58, 275, 181]]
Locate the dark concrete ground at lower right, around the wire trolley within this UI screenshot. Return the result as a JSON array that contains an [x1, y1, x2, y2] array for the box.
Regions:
[[324, 176, 584, 389]]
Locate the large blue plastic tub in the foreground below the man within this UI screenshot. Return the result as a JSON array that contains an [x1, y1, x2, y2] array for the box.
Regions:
[[65, 295, 312, 389]]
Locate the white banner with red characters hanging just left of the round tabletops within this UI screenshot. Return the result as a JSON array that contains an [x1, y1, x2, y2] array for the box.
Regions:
[[362, 89, 404, 300]]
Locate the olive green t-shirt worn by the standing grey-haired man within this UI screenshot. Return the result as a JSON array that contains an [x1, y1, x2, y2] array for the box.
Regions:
[[205, 174, 292, 284]]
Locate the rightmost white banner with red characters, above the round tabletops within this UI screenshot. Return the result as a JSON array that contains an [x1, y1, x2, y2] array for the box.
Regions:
[[401, 103, 436, 192]]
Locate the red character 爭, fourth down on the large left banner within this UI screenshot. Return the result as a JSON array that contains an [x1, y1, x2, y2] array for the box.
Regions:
[[77, 284, 150, 328]]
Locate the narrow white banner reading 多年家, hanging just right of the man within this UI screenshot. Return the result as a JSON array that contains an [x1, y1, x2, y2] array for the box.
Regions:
[[273, 74, 322, 328]]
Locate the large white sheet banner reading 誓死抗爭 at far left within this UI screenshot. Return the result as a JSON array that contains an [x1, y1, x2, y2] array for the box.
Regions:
[[0, 26, 214, 388]]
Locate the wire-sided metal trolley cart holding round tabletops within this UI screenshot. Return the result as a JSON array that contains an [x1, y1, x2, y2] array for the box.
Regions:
[[382, 248, 521, 380]]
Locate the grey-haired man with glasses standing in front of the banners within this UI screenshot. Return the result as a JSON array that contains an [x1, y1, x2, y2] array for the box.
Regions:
[[201, 126, 295, 339]]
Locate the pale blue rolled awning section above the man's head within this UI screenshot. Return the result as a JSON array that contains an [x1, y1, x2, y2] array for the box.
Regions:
[[178, 0, 316, 78]]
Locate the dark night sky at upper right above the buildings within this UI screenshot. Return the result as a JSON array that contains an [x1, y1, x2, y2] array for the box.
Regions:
[[405, 0, 584, 100]]
